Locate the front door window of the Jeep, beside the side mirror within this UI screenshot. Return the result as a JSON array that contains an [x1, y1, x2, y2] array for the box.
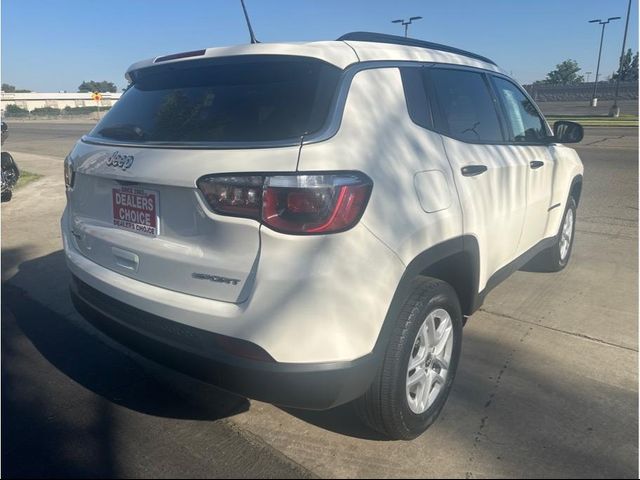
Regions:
[[493, 77, 548, 143]]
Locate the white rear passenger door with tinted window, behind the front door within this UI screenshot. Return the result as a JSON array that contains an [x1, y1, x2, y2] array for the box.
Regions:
[[425, 66, 528, 289]]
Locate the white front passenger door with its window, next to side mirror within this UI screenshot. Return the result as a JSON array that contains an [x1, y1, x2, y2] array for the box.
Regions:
[[492, 75, 556, 253]]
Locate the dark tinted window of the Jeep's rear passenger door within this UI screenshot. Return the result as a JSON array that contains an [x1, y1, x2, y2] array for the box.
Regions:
[[429, 68, 504, 143]]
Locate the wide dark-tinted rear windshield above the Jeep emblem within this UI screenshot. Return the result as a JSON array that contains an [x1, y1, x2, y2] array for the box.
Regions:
[[90, 56, 341, 143]]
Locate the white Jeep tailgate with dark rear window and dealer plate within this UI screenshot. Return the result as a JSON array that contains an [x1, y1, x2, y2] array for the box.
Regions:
[[68, 55, 340, 303]]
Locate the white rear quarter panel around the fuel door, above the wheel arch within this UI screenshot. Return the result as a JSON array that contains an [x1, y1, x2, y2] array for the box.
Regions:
[[299, 68, 462, 266]]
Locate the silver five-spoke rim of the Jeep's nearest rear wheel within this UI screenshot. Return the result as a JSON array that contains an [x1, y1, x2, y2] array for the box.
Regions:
[[407, 308, 453, 414]]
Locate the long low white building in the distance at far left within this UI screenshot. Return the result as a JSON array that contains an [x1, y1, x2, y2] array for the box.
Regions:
[[0, 92, 122, 112]]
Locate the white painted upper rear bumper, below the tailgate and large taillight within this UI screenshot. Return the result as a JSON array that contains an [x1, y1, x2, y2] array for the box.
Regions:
[[61, 208, 404, 364]]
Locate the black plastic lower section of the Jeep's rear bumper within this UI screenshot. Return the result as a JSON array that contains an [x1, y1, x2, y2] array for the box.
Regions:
[[71, 276, 379, 410]]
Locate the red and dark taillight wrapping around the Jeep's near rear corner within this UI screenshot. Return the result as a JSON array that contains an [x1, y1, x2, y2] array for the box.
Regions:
[[198, 172, 373, 235]]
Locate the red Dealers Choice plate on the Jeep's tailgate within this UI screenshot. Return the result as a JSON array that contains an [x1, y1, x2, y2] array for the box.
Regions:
[[112, 187, 160, 236]]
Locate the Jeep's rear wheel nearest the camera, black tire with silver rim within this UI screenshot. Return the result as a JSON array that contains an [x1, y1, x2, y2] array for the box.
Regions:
[[355, 277, 462, 440]]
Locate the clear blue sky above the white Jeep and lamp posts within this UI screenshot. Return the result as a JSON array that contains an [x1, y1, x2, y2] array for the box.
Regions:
[[0, 0, 638, 92]]
